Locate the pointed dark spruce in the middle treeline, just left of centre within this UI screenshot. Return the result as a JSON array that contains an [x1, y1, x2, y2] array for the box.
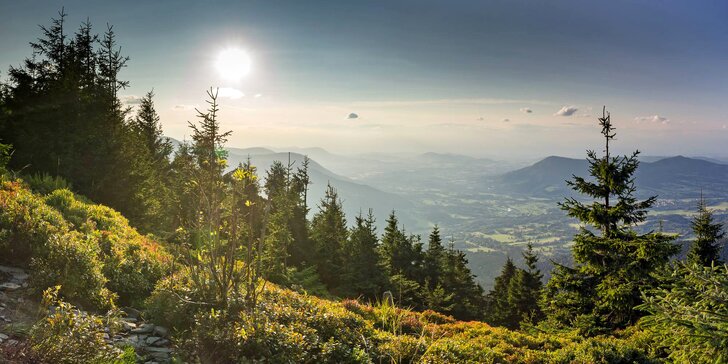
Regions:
[[311, 185, 349, 292]]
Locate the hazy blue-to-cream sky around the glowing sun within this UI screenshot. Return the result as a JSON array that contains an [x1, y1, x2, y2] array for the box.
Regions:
[[0, 0, 728, 158]]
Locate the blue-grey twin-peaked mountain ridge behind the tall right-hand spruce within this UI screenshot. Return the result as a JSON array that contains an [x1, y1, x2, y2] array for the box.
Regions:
[[492, 156, 728, 198]]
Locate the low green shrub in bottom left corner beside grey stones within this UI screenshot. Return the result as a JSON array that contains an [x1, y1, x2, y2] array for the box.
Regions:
[[30, 287, 136, 364]]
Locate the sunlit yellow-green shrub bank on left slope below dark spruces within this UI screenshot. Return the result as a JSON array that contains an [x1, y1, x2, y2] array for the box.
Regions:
[[0, 180, 170, 309]]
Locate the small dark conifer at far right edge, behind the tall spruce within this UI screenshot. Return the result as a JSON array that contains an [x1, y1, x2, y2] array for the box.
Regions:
[[688, 196, 725, 266]]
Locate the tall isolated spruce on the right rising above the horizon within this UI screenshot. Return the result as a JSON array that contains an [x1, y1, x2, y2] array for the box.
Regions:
[[544, 106, 678, 331]]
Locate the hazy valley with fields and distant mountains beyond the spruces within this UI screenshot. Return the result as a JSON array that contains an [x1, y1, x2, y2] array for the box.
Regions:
[[229, 148, 728, 290]]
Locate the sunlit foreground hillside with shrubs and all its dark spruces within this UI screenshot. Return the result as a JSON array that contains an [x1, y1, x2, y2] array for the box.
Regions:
[[0, 12, 728, 363]]
